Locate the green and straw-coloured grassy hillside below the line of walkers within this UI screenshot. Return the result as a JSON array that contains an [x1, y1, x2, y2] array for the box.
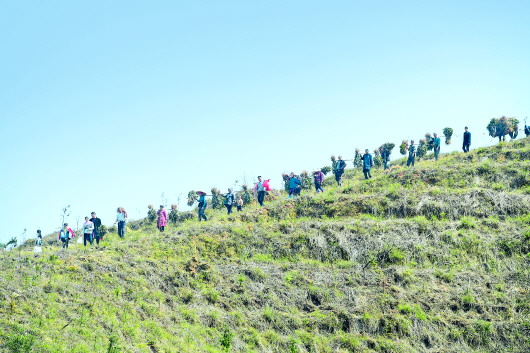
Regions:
[[0, 140, 530, 353]]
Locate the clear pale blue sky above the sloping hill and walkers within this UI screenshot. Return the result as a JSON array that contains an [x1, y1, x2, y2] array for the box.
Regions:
[[0, 0, 530, 241]]
